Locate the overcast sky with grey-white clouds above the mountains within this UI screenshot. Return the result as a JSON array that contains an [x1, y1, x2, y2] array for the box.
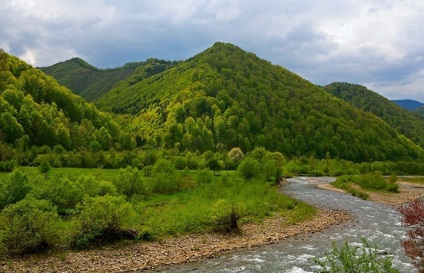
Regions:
[[0, 0, 424, 102]]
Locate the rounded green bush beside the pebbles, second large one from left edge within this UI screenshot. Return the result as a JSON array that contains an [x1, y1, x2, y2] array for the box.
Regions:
[[71, 195, 137, 248]]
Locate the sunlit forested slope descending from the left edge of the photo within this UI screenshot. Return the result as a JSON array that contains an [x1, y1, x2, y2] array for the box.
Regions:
[[0, 51, 120, 151]]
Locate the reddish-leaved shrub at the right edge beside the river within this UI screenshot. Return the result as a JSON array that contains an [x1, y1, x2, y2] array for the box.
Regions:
[[398, 197, 424, 273]]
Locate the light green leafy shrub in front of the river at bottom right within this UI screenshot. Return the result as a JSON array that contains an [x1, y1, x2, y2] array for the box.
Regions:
[[315, 239, 399, 273]]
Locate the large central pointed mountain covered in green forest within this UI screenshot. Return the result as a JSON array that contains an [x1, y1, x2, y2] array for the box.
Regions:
[[96, 43, 423, 161]]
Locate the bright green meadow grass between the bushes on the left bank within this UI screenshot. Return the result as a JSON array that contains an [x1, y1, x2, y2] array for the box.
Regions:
[[0, 167, 316, 252]]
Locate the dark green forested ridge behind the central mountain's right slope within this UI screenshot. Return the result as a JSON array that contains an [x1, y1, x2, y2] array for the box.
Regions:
[[324, 82, 424, 147]]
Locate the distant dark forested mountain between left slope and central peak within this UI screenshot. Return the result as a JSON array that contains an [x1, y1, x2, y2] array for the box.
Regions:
[[40, 58, 178, 101]]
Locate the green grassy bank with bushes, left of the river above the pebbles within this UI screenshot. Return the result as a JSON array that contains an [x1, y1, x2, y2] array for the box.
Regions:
[[0, 165, 316, 255]]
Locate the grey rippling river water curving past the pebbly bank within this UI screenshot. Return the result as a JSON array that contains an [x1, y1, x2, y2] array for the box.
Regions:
[[144, 178, 417, 273]]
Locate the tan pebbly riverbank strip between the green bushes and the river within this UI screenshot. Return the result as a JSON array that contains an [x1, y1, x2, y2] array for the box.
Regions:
[[0, 207, 351, 272]]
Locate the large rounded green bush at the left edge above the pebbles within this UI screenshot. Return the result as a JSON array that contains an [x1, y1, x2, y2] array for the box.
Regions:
[[2, 196, 58, 255]]
